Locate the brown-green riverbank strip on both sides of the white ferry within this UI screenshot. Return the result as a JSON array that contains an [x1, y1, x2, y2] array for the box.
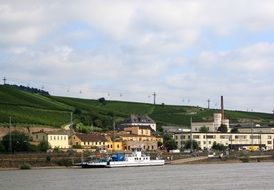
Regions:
[[0, 152, 274, 171]]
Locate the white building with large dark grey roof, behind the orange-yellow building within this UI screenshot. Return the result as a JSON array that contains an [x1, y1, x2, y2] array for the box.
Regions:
[[121, 114, 156, 131]]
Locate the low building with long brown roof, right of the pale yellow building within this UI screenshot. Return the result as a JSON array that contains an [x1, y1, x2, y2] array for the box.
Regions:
[[70, 133, 107, 150]]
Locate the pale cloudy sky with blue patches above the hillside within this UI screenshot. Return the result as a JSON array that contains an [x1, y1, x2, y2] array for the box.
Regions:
[[0, 0, 274, 113]]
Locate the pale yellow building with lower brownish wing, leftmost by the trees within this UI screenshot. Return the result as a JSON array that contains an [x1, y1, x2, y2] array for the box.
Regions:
[[31, 130, 70, 149]]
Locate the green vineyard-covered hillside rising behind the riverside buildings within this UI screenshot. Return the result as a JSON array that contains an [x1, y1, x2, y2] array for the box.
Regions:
[[0, 85, 274, 129]]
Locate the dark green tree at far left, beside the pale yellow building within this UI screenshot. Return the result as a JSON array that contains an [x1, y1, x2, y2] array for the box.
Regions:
[[2, 131, 30, 152]]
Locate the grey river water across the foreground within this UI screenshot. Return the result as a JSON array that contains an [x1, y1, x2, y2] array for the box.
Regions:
[[0, 162, 274, 190]]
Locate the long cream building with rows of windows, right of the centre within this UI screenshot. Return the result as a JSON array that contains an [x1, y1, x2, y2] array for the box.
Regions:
[[173, 132, 274, 150]]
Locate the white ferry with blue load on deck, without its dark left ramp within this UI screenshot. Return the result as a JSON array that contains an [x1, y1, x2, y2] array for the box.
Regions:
[[106, 149, 165, 168]]
